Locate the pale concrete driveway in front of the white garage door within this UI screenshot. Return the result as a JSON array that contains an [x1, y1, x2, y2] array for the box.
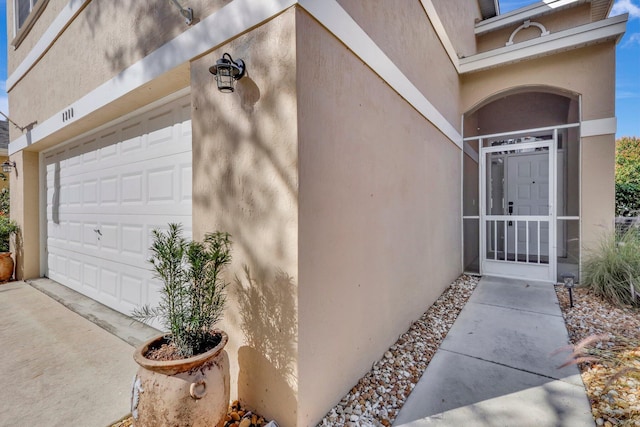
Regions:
[[0, 279, 158, 427]]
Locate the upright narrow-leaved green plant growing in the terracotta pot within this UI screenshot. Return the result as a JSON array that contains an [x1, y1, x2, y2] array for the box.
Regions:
[[133, 224, 231, 357]]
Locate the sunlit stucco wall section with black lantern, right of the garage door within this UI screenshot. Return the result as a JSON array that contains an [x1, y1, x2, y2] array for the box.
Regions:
[[191, 9, 298, 427]]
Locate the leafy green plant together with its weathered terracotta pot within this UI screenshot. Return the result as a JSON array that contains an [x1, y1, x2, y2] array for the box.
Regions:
[[131, 224, 231, 427]]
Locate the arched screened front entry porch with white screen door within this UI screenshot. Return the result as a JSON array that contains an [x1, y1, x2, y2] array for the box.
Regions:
[[463, 87, 580, 282]]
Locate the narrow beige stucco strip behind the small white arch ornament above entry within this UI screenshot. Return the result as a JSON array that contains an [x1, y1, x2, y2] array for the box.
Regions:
[[478, 2, 591, 52]]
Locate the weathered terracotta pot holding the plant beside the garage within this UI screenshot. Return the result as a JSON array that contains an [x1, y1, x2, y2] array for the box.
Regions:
[[131, 330, 229, 427]]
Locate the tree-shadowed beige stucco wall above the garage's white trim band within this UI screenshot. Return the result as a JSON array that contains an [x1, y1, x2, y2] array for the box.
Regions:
[[7, 0, 227, 140]]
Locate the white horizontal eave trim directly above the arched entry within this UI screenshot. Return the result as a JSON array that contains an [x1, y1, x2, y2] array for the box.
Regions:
[[460, 14, 629, 74]]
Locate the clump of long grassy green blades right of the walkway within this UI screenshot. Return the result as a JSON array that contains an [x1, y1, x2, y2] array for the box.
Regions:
[[582, 227, 640, 305]]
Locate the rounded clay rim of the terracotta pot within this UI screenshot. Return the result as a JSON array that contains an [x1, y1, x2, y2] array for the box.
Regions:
[[133, 329, 229, 375]]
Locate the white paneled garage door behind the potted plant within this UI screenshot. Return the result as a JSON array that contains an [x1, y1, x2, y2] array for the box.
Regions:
[[44, 98, 191, 314]]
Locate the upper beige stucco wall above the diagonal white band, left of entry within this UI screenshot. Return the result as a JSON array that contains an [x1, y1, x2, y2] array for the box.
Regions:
[[338, 0, 460, 131]]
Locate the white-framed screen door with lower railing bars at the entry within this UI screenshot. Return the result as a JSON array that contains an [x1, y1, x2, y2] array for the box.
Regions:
[[480, 140, 556, 280]]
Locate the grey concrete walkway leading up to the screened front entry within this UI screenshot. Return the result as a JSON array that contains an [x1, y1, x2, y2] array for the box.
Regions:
[[394, 277, 595, 427]]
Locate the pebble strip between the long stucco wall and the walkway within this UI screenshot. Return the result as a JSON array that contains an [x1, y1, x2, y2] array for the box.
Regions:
[[318, 275, 479, 427]]
